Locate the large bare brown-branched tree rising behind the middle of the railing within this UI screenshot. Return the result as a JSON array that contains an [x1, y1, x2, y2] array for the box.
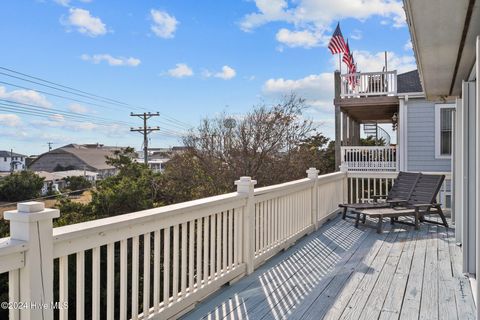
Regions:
[[184, 94, 314, 190]]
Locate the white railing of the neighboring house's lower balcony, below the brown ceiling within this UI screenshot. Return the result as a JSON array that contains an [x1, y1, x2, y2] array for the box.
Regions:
[[341, 146, 398, 172]]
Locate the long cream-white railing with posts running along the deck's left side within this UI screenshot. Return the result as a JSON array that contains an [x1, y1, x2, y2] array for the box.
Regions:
[[0, 169, 347, 319]]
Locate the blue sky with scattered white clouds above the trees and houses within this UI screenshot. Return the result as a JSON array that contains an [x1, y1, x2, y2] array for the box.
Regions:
[[0, 0, 415, 154]]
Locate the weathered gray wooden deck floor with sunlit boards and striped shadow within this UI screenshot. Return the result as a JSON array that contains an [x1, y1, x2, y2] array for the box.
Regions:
[[182, 217, 475, 320]]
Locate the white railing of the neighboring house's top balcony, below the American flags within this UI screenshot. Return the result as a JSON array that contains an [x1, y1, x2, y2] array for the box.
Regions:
[[340, 71, 397, 98]]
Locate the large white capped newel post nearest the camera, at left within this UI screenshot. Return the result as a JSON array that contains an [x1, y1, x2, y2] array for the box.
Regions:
[[4, 202, 60, 320]]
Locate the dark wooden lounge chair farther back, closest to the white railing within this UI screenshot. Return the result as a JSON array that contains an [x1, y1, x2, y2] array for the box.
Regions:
[[338, 171, 420, 219]]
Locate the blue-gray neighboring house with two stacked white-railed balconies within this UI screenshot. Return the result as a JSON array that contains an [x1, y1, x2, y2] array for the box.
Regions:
[[334, 70, 455, 178]]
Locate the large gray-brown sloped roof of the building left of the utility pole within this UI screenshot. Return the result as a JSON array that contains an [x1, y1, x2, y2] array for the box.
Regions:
[[29, 144, 120, 178]]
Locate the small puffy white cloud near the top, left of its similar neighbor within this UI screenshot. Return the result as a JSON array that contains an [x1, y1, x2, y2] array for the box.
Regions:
[[63, 8, 107, 37]]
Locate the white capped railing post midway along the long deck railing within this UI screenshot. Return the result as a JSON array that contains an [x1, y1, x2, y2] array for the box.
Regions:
[[235, 177, 257, 274]]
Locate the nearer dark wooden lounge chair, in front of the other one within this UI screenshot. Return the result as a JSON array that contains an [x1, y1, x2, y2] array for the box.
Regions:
[[355, 174, 448, 233]]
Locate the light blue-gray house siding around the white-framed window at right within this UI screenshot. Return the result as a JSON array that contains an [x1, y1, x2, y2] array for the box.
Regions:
[[406, 99, 451, 172]]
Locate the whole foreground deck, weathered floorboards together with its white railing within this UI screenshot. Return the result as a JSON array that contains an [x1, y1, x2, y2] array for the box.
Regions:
[[0, 168, 462, 320]]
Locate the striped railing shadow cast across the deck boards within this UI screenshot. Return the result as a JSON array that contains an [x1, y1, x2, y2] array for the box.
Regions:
[[183, 219, 371, 320]]
